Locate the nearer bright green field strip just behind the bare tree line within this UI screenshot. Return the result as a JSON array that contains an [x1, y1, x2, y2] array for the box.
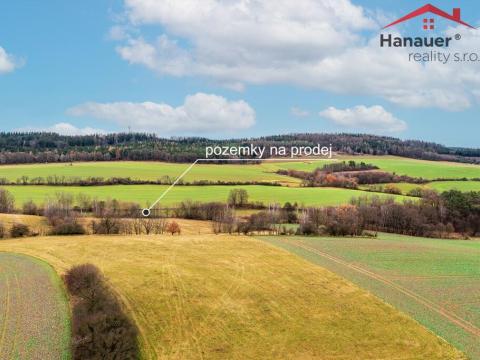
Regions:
[[2, 185, 411, 206]]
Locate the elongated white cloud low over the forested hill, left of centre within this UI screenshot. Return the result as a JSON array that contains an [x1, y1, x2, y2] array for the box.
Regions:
[[67, 93, 255, 134]]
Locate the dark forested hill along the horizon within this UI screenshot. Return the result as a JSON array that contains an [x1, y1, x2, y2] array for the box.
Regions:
[[0, 133, 480, 164]]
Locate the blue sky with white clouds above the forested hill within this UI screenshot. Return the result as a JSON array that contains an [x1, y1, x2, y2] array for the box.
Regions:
[[0, 0, 480, 147]]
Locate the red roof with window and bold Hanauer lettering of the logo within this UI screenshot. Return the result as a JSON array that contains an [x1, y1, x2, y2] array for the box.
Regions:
[[380, 4, 475, 48]]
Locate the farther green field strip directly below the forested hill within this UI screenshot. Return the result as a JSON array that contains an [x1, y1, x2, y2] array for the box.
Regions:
[[0, 156, 480, 185]]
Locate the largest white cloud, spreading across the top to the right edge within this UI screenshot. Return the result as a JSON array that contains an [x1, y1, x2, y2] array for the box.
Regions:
[[113, 0, 480, 110]]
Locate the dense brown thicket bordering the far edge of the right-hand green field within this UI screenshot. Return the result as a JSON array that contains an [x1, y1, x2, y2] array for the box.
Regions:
[[299, 190, 480, 237]]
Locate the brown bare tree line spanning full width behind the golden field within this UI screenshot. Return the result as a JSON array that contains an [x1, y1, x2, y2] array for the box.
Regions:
[[0, 189, 480, 238]]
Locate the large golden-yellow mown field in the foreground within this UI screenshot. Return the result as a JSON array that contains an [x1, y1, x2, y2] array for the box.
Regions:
[[0, 235, 465, 360]]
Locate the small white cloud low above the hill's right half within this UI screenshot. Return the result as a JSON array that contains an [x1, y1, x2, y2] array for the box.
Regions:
[[320, 105, 407, 132]]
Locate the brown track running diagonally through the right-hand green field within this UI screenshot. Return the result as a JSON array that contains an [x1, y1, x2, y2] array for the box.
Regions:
[[280, 239, 480, 337]]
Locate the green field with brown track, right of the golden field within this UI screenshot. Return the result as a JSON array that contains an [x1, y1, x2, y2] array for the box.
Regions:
[[262, 234, 480, 359]]
